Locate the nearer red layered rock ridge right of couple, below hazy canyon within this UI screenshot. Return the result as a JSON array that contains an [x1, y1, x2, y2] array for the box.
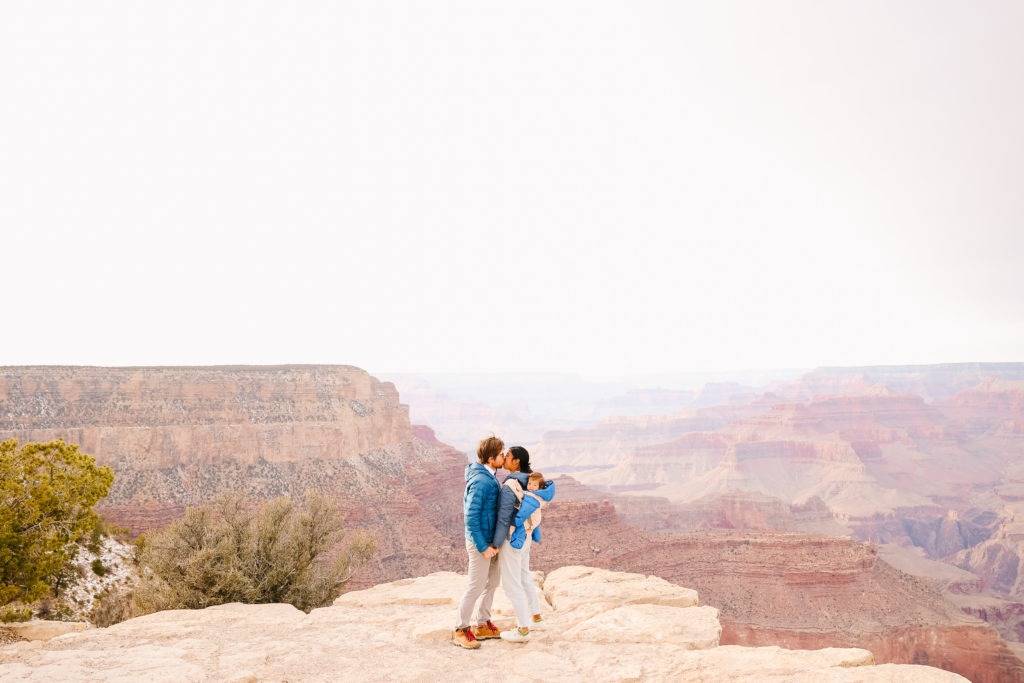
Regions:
[[531, 501, 1024, 683]]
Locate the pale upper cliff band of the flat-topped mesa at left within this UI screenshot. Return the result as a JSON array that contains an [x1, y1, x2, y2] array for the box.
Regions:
[[0, 366, 410, 467]]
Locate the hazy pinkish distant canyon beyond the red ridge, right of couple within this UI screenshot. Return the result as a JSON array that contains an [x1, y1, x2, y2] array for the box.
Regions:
[[534, 364, 1024, 655]]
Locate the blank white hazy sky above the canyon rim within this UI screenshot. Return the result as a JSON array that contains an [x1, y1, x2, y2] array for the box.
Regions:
[[0, 0, 1024, 375]]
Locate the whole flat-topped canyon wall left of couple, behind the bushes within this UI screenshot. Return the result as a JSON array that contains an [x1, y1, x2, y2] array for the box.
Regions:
[[0, 366, 466, 586]]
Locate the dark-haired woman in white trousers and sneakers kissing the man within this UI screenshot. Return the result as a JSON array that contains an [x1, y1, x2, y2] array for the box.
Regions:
[[492, 445, 555, 643]]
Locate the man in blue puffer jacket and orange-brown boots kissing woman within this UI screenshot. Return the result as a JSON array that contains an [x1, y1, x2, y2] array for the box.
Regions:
[[452, 436, 505, 649]]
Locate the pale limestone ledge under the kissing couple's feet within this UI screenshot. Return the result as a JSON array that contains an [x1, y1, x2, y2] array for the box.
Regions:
[[0, 567, 966, 683]]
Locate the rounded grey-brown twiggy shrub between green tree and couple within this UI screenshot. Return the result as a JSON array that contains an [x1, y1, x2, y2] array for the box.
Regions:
[[133, 492, 376, 614]]
